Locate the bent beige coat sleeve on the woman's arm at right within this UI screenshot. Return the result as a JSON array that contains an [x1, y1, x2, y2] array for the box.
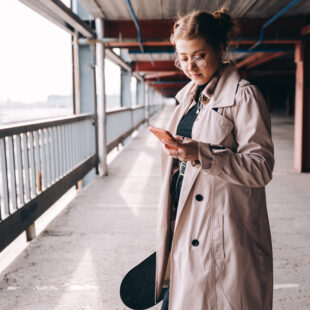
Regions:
[[198, 85, 274, 187]]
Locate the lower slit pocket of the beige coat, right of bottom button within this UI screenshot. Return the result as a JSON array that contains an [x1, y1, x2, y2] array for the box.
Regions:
[[212, 214, 225, 260]]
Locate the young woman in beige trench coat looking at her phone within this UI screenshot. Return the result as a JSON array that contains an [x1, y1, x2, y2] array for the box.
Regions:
[[156, 11, 274, 310]]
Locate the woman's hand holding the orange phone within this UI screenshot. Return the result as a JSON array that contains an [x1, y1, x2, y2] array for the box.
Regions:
[[162, 136, 198, 162]]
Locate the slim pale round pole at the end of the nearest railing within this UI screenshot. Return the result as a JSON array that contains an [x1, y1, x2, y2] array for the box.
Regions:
[[96, 18, 108, 176]]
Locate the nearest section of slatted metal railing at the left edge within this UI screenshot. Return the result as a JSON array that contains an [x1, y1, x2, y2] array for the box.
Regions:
[[0, 114, 97, 251]]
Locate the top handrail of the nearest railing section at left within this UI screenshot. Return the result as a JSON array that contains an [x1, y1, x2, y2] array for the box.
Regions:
[[0, 113, 95, 138]]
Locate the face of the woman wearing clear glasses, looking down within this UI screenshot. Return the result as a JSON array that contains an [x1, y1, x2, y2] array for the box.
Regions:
[[175, 38, 220, 85]]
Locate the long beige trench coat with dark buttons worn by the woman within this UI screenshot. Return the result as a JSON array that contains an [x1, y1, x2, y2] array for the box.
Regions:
[[156, 64, 274, 310]]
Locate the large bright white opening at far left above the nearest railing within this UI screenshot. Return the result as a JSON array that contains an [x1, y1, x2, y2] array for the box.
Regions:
[[0, 0, 73, 126]]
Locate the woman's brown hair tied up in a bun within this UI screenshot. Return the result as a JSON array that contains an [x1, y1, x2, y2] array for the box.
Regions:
[[170, 9, 234, 51]]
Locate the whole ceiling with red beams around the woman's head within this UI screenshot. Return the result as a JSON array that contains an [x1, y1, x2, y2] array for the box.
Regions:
[[79, 0, 310, 97]]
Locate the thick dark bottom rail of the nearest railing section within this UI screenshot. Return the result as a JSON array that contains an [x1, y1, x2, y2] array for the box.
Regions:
[[0, 155, 97, 251]]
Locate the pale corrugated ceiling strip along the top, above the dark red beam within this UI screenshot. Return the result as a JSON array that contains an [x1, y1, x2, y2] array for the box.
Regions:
[[79, 0, 310, 20]]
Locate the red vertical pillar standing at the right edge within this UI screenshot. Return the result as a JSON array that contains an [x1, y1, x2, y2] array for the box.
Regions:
[[294, 41, 310, 172]]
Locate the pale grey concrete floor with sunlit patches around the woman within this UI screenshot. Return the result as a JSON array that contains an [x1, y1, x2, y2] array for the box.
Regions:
[[0, 109, 310, 310]]
